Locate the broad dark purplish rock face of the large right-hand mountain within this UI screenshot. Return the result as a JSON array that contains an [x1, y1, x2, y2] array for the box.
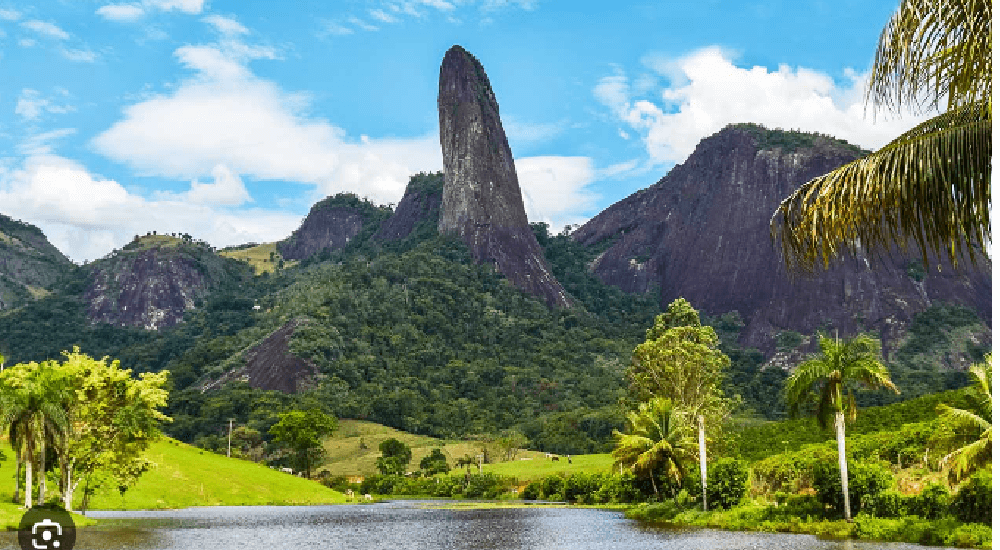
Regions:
[[573, 124, 992, 351]]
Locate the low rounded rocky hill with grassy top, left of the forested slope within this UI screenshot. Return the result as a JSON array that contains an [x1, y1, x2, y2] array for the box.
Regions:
[[83, 235, 252, 330]]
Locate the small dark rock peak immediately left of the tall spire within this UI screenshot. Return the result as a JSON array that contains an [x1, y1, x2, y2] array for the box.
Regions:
[[373, 172, 444, 241]]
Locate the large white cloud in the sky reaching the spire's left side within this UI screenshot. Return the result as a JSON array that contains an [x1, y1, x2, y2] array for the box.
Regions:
[[92, 38, 441, 207]]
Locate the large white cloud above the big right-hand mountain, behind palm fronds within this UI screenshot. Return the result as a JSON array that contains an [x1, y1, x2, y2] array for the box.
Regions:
[[594, 47, 926, 164]]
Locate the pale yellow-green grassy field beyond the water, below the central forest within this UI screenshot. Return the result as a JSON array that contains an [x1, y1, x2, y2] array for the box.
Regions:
[[317, 420, 612, 483]]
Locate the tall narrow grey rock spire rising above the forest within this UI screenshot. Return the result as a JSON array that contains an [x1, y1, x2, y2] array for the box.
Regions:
[[438, 46, 571, 307]]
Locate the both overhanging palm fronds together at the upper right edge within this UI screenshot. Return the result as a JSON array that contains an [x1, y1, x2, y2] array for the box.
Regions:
[[771, 0, 993, 270]]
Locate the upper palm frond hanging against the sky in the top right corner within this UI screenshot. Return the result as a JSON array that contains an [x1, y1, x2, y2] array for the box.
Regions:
[[868, 0, 993, 114]]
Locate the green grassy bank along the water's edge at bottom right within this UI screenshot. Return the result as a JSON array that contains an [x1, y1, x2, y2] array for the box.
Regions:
[[625, 502, 993, 549]]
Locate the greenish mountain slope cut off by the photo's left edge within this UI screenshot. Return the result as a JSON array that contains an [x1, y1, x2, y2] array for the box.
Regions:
[[0, 214, 75, 310]]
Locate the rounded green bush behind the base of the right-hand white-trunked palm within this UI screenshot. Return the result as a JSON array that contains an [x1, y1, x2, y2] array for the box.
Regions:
[[813, 461, 892, 515]]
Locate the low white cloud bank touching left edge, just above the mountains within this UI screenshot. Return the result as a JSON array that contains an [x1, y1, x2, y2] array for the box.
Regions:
[[0, 154, 302, 262]]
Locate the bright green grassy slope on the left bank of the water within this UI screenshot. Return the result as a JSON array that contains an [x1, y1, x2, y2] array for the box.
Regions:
[[0, 438, 345, 520]]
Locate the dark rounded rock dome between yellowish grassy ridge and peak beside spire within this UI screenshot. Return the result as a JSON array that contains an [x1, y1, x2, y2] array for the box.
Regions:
[[278, 195, 365, 260]]
